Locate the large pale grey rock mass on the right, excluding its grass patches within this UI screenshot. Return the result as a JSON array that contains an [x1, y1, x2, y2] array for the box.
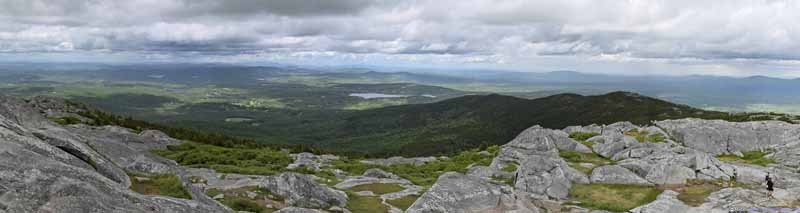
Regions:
[[408, 119, 800, 213]]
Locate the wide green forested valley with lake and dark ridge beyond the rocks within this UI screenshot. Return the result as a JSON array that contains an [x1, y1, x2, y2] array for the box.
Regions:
[[0, 64, 797, 157]]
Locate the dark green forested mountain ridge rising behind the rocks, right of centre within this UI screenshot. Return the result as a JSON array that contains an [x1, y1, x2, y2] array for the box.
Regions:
[[317, 92, 776, 156]]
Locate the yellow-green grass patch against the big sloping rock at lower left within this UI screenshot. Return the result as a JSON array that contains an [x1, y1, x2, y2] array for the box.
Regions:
[[129, 174, 192, 199]]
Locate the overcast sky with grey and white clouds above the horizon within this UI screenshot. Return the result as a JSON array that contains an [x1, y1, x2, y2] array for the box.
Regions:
[[0, 0, 800, 77]]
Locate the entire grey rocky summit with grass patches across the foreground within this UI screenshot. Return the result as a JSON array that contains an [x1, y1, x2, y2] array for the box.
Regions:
[[0, 96, 800, 213]]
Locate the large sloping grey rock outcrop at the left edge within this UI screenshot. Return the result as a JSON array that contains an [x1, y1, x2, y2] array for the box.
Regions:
[[0, 96, 228, 212]]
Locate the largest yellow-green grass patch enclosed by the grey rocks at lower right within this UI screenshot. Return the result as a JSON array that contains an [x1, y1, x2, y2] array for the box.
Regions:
[[569, 184, 663, 212]]
